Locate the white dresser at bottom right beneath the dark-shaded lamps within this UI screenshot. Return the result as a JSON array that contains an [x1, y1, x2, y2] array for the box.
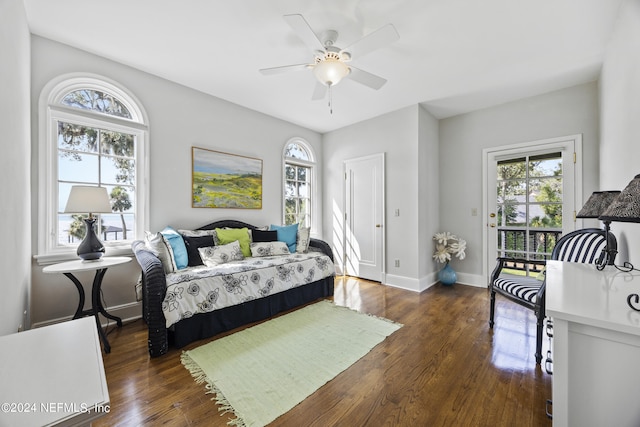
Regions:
[[546, 261, 640, 427]]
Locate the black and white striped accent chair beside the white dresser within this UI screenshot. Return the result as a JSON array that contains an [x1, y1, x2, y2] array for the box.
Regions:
[[489, 228, 617, 364]]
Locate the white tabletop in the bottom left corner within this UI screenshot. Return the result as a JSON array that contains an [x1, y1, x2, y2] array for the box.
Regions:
[[0, 318, 110, 427]]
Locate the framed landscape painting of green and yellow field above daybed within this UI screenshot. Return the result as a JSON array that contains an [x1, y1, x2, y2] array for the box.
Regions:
[[191, 147, 262, 209]]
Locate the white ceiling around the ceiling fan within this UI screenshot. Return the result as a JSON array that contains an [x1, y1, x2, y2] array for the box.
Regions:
[[24, 0, 624, 133]]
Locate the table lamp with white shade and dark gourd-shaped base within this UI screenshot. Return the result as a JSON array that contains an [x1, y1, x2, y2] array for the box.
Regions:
[[64, 185, 111, 261]]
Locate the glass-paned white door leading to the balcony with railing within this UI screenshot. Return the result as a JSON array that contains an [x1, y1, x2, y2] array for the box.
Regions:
[[483, 135, 582, 279]]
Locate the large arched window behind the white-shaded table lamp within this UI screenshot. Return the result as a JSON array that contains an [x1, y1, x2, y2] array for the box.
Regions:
[[38, 76, 147, 259]]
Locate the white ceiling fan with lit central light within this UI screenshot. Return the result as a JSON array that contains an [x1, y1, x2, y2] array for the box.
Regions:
[[260, 14, 400, 110]]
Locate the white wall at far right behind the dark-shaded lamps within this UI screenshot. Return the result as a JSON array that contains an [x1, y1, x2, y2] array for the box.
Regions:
[[600, 0, 640, 267]]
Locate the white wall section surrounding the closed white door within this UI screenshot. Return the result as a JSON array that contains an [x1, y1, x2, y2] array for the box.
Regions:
[[323, 105, 437, 290]]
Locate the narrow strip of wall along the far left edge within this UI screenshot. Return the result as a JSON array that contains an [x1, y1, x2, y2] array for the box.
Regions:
[[0, 0, 31, 335]]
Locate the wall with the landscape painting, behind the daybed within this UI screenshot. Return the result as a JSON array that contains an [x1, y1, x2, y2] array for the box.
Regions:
[[31, 36, 322, 324]]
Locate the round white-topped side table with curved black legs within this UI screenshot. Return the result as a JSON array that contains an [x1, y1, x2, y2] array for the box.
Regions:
[[42, 257, 131, 353]]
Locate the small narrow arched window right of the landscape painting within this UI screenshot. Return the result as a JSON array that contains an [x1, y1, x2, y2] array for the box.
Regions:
[[282, 138, 316, 227]]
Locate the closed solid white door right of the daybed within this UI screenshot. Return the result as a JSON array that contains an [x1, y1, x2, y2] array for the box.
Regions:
[[344, 153, 384, 282]]
